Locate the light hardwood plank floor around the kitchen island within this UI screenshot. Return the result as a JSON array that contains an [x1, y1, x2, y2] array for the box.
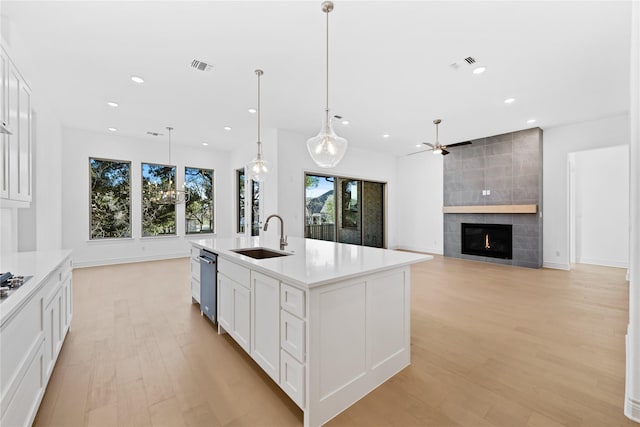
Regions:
[[34, 257, 638, 427]]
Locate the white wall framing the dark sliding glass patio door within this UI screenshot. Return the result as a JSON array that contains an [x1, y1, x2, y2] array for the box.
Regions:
[[278, 130, 398, 248]]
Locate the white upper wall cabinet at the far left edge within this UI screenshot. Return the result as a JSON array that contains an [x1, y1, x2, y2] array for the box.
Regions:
[[0, 47, 33, 207]]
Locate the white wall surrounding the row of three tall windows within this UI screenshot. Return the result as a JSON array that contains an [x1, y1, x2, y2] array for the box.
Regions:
[[61, 128, 232, 266]]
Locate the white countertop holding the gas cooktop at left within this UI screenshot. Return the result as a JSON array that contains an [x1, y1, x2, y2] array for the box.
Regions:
[[0, 249, 71, 325]]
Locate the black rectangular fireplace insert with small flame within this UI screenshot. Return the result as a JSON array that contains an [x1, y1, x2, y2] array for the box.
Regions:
[[462, 222, 513, 259]]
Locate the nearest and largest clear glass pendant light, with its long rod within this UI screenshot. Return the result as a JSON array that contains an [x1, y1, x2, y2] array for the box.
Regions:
[[307, 1, 348, 168]]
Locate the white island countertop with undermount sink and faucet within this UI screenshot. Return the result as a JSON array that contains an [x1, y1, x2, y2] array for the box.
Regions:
[[191, 237, 433, 288]]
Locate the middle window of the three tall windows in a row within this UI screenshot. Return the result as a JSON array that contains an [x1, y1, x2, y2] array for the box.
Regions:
[[142, 163, 176, 237]]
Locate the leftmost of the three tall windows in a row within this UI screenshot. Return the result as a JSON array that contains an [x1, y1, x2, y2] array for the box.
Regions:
[[89, 157, 131, 240]]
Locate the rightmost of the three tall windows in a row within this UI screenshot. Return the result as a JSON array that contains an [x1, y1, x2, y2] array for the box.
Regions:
[[184, 167, 214, 234]]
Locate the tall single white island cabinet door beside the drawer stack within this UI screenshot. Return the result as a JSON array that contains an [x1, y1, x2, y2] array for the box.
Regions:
[[251, 271, 280, 382]]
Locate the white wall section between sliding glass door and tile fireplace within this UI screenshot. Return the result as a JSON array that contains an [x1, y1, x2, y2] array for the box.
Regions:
[[396, 152, 444, 254]]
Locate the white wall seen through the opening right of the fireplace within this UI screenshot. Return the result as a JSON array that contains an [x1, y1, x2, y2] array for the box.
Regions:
[[572, 145, 629, 268]]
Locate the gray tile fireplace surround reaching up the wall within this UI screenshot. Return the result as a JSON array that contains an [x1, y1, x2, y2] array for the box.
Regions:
[[444, 128, 542, 268]]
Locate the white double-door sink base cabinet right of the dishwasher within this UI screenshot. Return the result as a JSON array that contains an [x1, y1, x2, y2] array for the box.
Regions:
[[218, 258, 251, 354]]
